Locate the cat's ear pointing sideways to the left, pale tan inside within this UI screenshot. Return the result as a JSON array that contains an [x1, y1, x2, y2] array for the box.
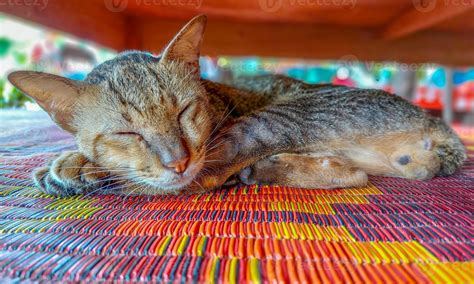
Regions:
[[8, 71, 85, 133]]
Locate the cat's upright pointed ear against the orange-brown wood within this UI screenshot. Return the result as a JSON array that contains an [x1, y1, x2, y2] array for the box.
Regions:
[[161, 15, 207, 70]]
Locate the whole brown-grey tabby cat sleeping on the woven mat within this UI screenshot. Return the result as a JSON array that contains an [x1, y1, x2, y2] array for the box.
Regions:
[[9, 16, 466, 196]]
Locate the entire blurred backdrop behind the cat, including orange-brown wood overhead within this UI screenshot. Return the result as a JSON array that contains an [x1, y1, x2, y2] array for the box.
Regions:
[[0, 0, 474, 126]]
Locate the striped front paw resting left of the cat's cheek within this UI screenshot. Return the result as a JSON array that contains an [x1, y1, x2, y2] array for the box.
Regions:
[[33, 152, 108, 197]]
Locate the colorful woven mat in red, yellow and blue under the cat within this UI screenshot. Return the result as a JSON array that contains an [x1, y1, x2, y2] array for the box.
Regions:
[[0, 110, 474, 283]]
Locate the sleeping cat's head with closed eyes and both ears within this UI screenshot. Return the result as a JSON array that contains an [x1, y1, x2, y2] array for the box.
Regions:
[[8, 16, 211, 193]]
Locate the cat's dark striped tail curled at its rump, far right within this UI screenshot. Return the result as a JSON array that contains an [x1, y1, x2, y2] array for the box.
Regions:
[[432, 119, 467, 176]]
